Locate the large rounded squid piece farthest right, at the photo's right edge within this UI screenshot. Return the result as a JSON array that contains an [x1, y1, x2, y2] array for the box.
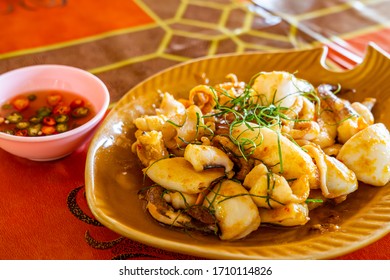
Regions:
[[337, 123, 390, 186]]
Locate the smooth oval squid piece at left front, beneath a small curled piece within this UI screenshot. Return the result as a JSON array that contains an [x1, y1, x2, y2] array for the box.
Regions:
[[145, 157, 225, 194]]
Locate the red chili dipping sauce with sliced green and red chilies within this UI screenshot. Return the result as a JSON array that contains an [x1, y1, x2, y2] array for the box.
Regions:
[[0, 90, 96, 136]]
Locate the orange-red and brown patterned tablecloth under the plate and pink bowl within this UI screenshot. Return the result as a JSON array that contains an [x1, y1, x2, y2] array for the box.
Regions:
[[0, 0, 390, 260]]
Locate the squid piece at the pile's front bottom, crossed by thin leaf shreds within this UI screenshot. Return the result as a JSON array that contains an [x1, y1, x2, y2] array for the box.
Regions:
[[203, 180, 260, 240]]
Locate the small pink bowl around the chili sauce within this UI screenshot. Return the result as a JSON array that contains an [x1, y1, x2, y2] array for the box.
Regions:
[[0, 65, 110, 161]]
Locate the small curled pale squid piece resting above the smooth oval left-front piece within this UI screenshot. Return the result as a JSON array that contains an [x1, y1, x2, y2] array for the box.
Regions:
[[184, 144, 234, 173]]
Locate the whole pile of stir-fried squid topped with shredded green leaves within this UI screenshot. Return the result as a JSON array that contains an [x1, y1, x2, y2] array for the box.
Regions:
[[132, 71, 390, 240]]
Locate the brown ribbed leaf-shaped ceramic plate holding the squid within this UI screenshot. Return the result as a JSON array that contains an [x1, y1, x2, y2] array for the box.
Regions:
[[85, 46, 390, 259]]
